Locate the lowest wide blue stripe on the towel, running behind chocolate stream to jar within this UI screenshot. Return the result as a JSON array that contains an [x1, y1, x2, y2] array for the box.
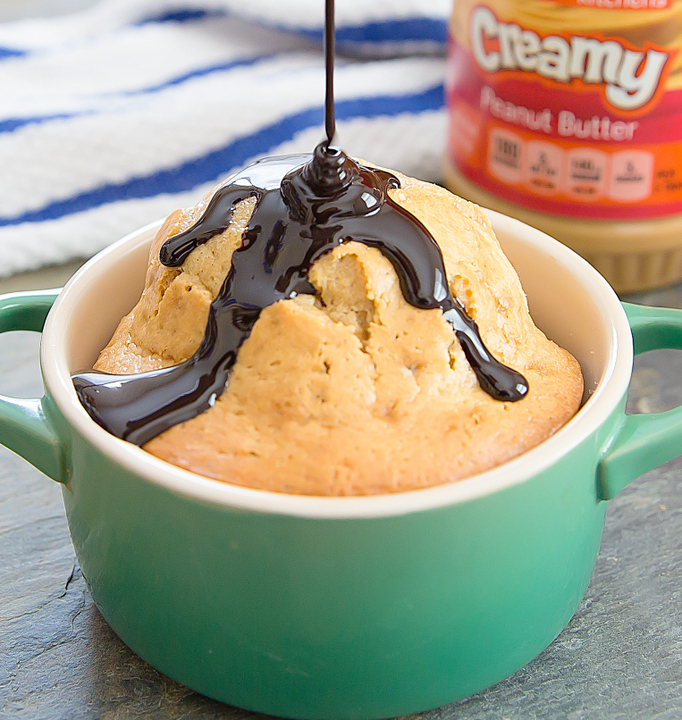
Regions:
[[0, 85, 443, 227]]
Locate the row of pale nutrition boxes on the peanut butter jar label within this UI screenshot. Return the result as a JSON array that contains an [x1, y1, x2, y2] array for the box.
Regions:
[[487, 128, 655, 203]]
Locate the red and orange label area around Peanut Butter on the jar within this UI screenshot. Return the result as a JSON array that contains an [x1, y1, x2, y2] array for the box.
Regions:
[[448, 33, 682, 219]]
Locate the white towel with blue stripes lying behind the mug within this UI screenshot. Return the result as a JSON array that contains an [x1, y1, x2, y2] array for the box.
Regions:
[[0, 0, 450, 275]]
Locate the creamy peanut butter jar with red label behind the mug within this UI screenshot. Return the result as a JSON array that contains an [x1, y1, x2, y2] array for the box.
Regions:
[[445, 0, 682, 292]]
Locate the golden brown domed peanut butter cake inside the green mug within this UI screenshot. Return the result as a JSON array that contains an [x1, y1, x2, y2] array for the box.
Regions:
[[95, 167, 583, 495]]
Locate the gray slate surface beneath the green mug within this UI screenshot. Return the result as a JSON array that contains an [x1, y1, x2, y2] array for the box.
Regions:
[[0, 284, 682, 720]]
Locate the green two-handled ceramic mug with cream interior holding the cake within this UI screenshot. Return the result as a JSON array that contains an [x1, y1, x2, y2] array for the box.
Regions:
[[0, 213, 682, 719]]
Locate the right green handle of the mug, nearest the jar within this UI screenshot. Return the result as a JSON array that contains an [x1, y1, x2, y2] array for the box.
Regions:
[[597, 302, 682, 500]]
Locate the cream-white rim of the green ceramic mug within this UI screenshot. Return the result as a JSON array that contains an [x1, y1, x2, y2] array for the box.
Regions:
[[41, 211, 633, 518]]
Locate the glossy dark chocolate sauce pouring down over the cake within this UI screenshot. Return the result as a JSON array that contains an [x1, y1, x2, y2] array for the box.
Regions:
[[73, 0, 528, 445]]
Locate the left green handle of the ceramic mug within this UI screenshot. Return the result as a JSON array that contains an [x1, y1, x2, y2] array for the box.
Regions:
[[0, 288, 67, 483]]
